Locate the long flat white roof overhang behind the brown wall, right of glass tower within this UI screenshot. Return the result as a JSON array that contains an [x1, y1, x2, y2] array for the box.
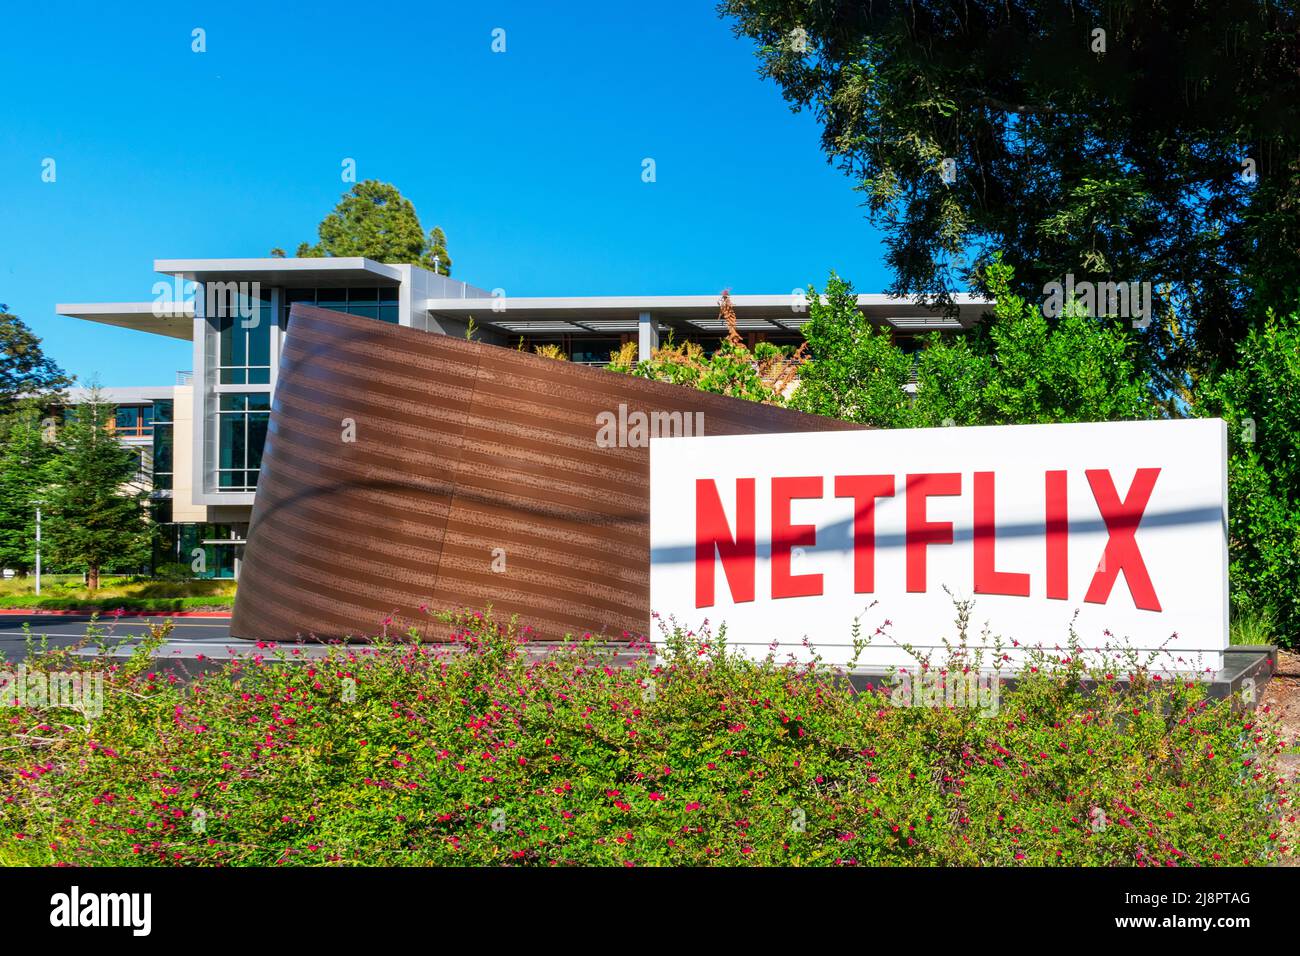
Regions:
[[424, 294, 993, 334]]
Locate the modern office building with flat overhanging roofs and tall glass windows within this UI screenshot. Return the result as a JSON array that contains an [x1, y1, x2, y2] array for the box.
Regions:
[[56, 258, 989, 576]]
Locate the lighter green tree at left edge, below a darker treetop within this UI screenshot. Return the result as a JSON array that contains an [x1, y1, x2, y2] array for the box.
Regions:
[[0, 403, 55, 574]]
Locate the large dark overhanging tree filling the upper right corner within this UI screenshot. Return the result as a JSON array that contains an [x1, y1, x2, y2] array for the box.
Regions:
[[719, 0, 1300, 394]]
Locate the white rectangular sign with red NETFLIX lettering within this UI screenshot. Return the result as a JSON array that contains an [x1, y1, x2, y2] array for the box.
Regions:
[[650, 419, 1227, 671]]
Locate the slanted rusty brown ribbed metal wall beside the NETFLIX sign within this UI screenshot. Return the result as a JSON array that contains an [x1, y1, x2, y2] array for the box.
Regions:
[[230, 304, 857, 640]]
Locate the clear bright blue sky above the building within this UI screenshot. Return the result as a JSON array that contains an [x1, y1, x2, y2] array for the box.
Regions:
[[0, 0, 888, 385]]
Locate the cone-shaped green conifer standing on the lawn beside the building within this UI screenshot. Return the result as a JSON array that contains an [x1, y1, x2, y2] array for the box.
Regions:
[[46, 388, 150, 591]]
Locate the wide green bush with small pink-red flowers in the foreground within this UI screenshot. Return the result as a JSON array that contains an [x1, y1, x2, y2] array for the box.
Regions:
[[0, 614, 1295, 866]]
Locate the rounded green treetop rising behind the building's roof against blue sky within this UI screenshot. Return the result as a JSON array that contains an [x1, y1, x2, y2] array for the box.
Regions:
[[289, 179, 451, 276]]
